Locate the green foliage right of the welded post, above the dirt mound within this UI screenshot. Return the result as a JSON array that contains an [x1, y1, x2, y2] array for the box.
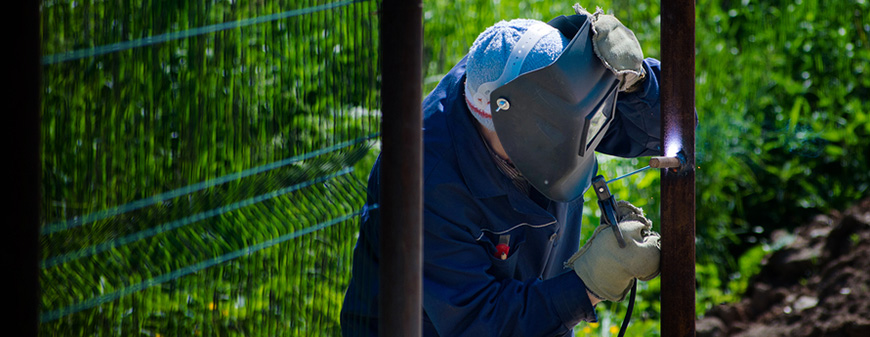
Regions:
[[697, 0, 870, 291]]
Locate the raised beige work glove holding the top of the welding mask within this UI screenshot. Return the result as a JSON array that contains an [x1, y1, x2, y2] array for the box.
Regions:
[[574, 4, 646, 92]]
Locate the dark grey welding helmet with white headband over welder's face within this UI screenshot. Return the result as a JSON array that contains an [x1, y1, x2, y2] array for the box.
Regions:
[[466, 15, 619, 201]]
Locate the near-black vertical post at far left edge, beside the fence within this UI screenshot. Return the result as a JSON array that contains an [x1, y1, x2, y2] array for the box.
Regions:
[[0, 1, 42, 336]]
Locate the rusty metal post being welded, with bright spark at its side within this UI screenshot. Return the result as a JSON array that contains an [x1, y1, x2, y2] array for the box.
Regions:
[[661, 0, 695, 337]]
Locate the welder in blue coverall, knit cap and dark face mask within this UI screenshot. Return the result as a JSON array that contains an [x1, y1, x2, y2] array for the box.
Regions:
[[341, 5, 661, 337]]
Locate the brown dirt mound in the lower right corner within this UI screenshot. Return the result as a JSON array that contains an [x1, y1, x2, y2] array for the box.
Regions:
[[696, 198, 870, 337]]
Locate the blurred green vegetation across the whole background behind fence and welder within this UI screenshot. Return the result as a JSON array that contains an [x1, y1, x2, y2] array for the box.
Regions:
[[41, 0, 870, 336]]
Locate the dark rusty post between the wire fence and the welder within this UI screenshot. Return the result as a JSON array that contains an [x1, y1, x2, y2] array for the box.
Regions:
[[378, 0, 423, 336]]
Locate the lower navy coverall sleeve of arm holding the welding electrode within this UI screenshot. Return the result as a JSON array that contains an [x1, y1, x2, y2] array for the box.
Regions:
[[423, 203, 596, 337]]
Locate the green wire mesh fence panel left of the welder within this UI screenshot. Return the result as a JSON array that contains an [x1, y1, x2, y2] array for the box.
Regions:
[[40, 0, 380, 336]]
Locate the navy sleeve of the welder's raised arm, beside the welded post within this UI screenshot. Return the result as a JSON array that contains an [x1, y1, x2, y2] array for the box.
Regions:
[[595, 58, 664, 157]]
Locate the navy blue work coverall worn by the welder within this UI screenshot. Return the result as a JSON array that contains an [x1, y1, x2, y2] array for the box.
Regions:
[[341, 53, 661, 337]]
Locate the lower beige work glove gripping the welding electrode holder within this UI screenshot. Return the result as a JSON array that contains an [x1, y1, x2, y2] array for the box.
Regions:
[[565, 200, 661, 302]]
